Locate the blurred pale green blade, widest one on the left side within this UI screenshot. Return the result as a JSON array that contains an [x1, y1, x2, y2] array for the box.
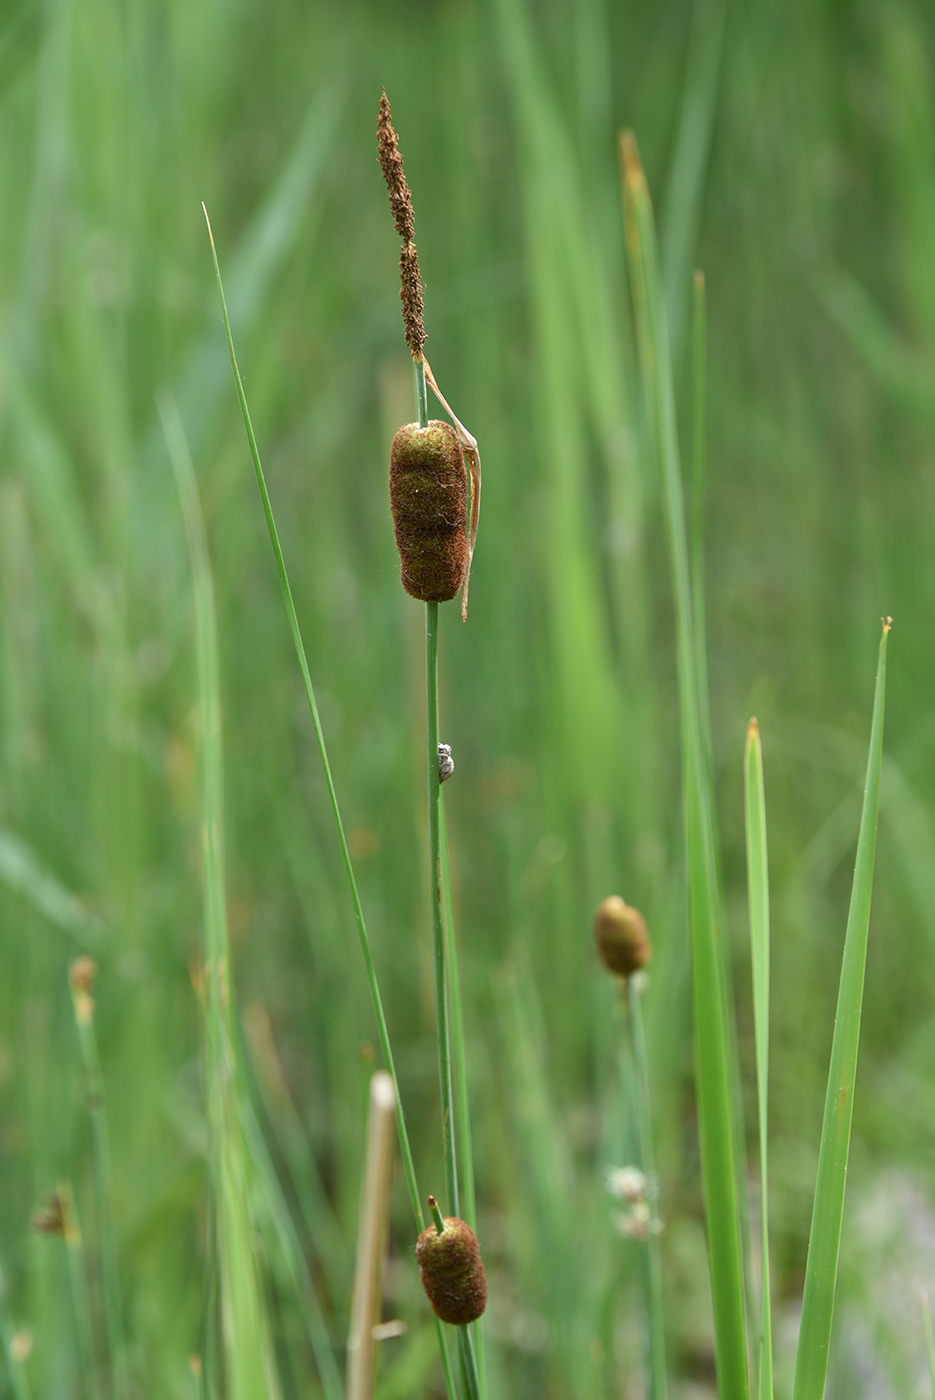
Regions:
[[160, 399, 280, 1400]]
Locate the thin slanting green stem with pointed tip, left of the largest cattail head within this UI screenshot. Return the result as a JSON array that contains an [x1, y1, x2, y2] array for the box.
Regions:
[[202, 206, 426, 1231]]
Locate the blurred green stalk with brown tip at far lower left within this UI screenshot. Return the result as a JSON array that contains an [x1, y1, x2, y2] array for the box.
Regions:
[[69, 958, 130, 1400]]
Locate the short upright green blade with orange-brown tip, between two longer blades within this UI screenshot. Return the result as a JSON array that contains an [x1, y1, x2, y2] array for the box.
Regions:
[[743, 720, 773, 1400]]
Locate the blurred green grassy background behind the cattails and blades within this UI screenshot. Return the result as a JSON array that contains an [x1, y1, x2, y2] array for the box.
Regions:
[[0, 0, 935, 1400]]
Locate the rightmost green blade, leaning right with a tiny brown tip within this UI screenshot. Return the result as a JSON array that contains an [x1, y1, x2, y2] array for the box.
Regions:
[[792, 617, 892, 1400]]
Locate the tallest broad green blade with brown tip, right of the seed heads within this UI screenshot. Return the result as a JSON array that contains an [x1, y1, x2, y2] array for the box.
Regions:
[[620, 133, 749, 1400]]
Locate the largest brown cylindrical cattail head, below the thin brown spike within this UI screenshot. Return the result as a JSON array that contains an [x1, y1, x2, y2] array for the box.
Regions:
[[389, 419, 468, 603]]
